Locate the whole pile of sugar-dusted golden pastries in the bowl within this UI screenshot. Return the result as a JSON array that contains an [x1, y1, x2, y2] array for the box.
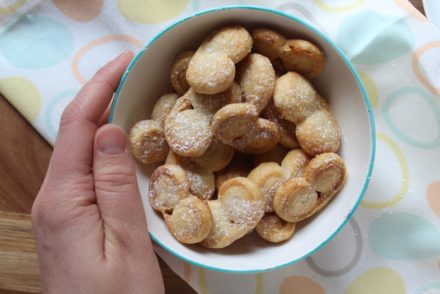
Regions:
[[130, 25, 346, 248]]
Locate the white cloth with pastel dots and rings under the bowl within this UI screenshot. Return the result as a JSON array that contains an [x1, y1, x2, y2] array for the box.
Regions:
[[0, 0, 440, 294]]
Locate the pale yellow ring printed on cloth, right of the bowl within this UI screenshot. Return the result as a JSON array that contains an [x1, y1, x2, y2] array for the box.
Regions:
[[361, 133, 409, 209]]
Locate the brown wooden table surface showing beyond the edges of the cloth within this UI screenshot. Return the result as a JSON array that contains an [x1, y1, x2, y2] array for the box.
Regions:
[[0, 0, 424, 294]]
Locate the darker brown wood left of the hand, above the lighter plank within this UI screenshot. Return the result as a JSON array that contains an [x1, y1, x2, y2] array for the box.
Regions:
[[0, 97, 52, 213]]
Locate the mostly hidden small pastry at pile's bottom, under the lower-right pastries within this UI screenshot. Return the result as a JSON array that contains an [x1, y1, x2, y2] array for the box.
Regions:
[[255, 214, 296, 243]]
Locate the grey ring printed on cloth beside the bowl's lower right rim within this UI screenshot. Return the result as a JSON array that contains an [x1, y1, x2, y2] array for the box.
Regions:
[[306, 218, 362, 277]]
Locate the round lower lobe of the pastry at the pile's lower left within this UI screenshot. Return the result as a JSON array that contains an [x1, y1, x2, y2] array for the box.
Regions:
[[163, 196, 212, 244]]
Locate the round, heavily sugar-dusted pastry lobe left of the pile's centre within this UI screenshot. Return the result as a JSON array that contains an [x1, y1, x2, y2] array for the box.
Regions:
[[165, 96, 213, 157]]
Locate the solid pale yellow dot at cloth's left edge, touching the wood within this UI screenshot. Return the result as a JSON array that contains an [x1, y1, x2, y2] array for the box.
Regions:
[[0, 77, 41, 122]]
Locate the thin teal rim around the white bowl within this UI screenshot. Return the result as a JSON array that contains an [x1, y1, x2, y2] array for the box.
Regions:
[[109, 5, 376, 274]]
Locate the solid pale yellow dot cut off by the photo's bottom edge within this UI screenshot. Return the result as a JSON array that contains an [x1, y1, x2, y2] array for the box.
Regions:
[[344, 267, 406, 294]]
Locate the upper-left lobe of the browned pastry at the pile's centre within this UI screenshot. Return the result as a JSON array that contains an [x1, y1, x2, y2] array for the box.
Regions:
[[211, 103, 258, 145]]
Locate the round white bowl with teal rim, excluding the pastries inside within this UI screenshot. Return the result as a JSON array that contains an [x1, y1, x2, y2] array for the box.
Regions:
[[110, 6, 375, 273]]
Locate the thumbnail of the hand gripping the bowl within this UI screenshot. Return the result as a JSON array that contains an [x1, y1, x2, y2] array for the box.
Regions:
[[97, 126, 127, 154]]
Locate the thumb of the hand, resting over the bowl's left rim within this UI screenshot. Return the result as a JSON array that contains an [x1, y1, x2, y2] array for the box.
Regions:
[[93, 125, 149, 246]]
